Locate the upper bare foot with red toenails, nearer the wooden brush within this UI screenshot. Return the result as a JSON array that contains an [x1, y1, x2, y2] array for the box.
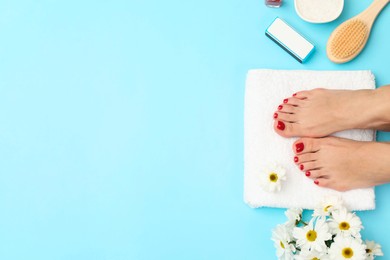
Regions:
[[274, 86, 390, 137]]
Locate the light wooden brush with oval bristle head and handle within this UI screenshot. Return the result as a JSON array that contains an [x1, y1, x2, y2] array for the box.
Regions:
[[326, 0, 390, 63]]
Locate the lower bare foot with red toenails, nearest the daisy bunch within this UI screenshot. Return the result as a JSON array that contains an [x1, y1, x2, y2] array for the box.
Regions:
[[293, 137, 390, 191]]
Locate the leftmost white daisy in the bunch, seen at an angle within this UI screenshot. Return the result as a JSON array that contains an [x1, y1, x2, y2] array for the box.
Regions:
[[272, 225, 296, 260]]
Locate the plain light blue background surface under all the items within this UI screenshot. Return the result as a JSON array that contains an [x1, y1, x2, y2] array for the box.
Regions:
[[0, 0, 390, 260]]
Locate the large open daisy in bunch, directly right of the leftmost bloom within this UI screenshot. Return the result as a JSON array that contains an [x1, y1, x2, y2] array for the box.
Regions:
[[293, 218, 332, 252]]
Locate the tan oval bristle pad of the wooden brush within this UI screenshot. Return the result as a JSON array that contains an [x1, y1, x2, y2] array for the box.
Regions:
[[328, 20, 369, 59]]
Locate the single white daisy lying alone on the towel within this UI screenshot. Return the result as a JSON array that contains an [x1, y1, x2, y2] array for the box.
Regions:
[[260, 165, 286, 192]]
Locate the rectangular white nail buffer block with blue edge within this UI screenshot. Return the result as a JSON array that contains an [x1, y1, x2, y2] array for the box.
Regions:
[[265, 17, 314, 63]]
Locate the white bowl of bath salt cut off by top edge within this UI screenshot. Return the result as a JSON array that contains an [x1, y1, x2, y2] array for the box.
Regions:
[[295, 0, 344, 23]]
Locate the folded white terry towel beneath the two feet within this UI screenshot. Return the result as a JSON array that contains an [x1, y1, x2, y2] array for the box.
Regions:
[[244, 70, 375, 210]]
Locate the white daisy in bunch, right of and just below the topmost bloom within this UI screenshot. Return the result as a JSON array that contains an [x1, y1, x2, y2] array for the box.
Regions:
[[329, 208, 363, 238]]
